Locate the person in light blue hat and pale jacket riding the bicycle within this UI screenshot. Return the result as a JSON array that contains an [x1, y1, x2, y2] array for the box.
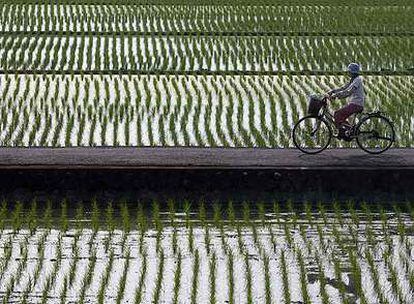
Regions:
[[327, 63, 365, 139]]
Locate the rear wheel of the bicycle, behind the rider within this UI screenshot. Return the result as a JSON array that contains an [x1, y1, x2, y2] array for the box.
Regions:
[[356, 115, 395, 154]]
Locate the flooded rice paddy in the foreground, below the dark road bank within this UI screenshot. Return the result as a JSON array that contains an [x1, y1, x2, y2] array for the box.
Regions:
[[0, 201, 414, 303]]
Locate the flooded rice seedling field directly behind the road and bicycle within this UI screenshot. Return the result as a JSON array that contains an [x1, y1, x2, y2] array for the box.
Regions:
[[0, 76, 413, 147]]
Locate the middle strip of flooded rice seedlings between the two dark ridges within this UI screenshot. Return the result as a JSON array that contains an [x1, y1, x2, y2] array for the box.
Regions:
[[0, 33, 412, 74]]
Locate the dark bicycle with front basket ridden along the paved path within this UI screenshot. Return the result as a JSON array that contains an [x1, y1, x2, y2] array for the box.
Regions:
[[292, 96, 395, 154]]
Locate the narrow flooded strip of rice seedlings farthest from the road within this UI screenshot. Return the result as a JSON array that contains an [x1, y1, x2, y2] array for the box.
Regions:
[[0, 0, 412, 35]]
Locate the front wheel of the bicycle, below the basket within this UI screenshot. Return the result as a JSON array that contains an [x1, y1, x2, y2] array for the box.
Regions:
[[292, 116, 332, 154]]
